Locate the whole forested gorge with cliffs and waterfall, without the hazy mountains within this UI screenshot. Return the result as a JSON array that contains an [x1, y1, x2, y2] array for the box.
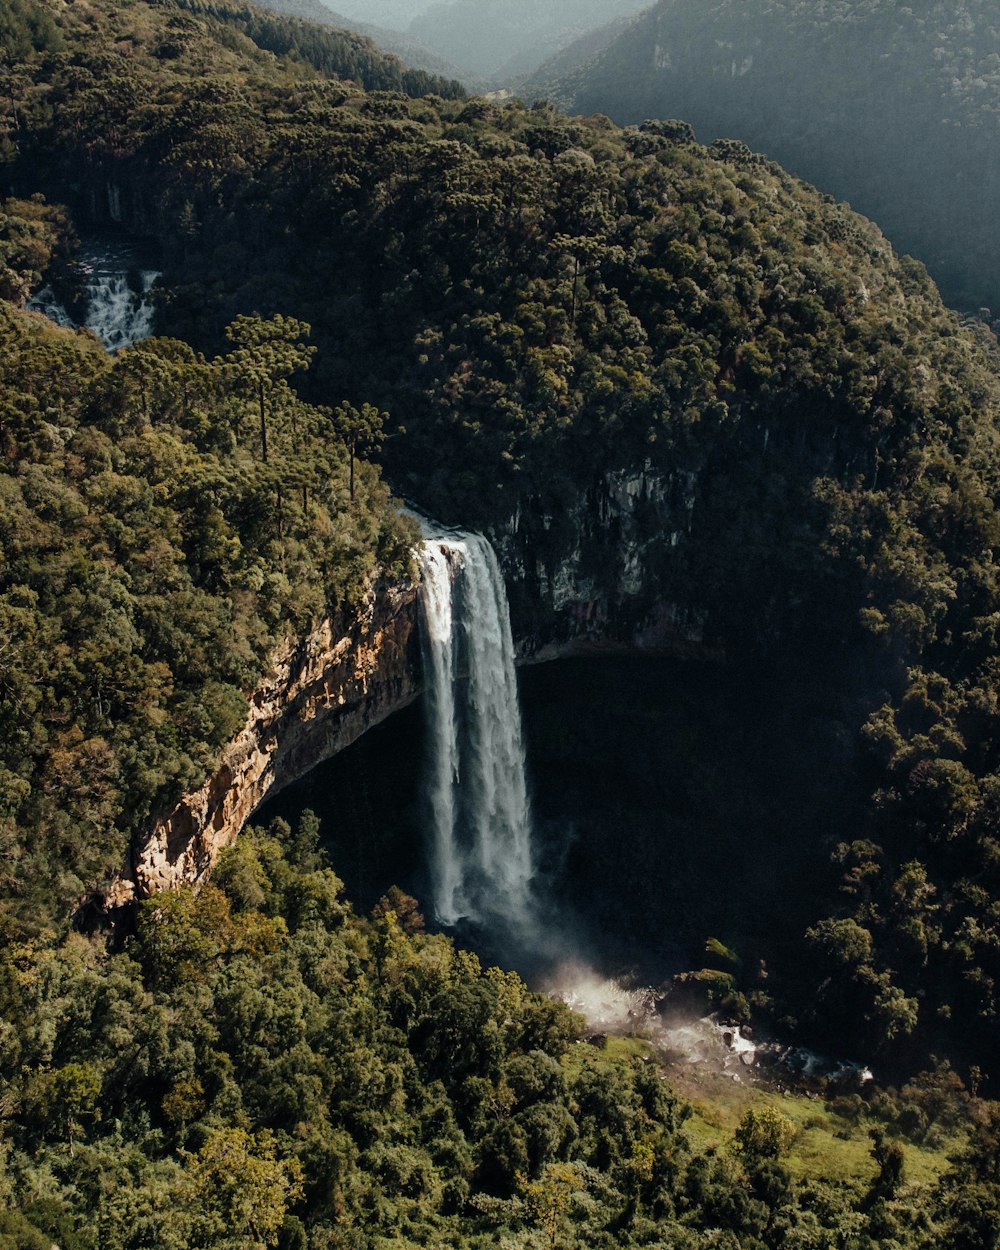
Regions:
[[9, 0, 1000, 1235]]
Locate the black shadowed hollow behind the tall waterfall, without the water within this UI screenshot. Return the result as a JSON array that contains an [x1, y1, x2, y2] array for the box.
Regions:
[[254, 656, 860, 983]]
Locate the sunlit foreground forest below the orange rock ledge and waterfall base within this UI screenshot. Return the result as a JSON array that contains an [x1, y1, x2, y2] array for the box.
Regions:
[[0, 819, 1000, 1250]]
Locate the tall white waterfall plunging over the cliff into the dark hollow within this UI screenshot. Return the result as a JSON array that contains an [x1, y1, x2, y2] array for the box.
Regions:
[[420, 531, 534, 935]]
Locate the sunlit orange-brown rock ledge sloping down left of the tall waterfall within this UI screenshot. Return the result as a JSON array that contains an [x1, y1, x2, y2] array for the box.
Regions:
[[100, 572, 421, 913]]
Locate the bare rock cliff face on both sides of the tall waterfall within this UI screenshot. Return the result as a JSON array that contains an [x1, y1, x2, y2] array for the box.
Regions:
[[100, 471, 701, 913]]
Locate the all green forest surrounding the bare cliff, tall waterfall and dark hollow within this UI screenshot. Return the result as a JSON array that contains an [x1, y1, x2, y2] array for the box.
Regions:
[[0, 0, 1000, 1250]]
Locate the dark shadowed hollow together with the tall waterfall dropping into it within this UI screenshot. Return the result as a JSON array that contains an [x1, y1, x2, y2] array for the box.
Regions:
[[260, 533, 850, 1005]]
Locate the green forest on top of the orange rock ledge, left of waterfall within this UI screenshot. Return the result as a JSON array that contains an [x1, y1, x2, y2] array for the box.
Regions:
[[0, 230, 410, 931]]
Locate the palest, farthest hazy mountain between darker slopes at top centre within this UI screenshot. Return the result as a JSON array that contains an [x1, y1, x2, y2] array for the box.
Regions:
[[408, 0, 646, 81]]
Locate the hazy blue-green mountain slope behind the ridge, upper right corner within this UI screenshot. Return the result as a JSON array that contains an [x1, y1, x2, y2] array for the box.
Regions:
[[526, 0, 1000, 309]]
